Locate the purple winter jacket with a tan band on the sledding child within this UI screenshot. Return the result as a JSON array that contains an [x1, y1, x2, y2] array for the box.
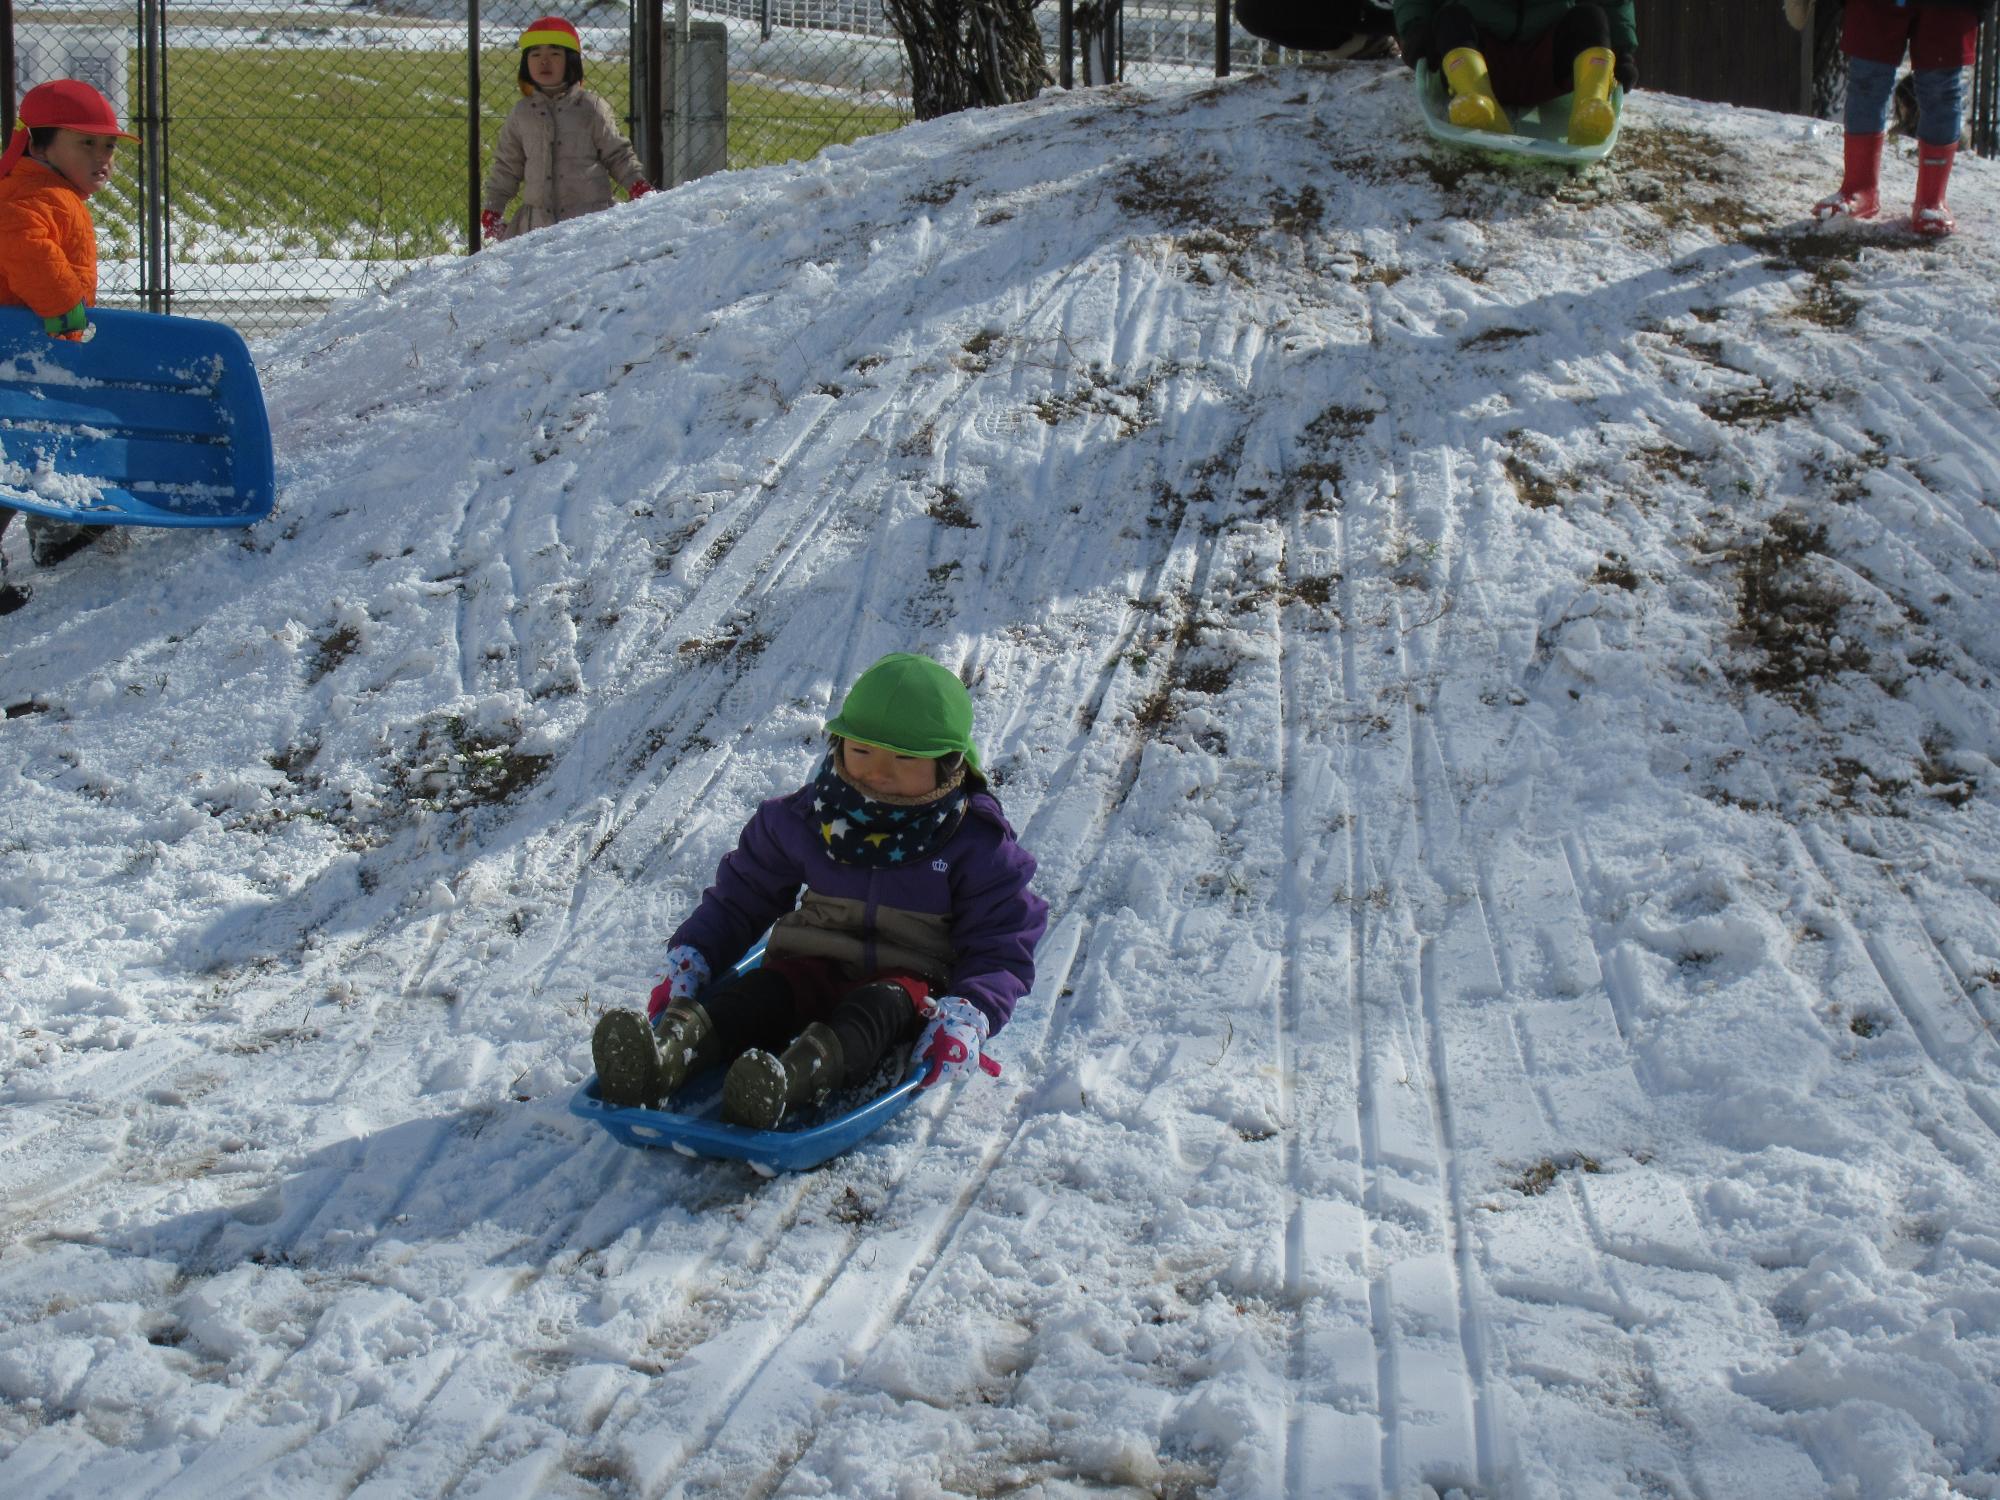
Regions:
[[670, 784, 1048, 1032]]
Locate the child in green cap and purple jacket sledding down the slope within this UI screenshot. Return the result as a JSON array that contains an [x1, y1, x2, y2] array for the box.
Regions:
[[590, 652, 1048, 1130]]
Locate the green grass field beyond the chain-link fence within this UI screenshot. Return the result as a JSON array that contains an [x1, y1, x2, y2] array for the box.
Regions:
[[94, 48, 908, 264]]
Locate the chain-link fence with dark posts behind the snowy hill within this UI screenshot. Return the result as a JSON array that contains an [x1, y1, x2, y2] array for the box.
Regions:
[[0, 0, 2000, 334]]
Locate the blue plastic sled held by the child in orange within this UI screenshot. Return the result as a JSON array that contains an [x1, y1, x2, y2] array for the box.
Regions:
[[0, 308, 278, 526]]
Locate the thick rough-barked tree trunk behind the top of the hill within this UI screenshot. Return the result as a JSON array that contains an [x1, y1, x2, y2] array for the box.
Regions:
[[882, 0, 1048, 120]]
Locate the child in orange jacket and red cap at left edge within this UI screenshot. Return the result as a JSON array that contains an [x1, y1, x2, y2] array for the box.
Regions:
[[0, 78, 138, 588]]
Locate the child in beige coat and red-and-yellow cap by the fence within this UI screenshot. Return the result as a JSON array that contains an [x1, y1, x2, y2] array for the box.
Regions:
[[480, 16, 652, 240]]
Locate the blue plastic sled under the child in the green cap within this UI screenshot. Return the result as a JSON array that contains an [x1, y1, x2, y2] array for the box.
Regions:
[[570, 942, 924, 1176]]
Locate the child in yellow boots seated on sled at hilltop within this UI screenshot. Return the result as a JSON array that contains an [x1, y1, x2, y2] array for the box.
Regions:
[[1396, 0, 1638, 146]]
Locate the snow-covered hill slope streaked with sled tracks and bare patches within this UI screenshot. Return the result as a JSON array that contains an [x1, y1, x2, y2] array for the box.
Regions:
[[0, 66, 2000, 1500]]
